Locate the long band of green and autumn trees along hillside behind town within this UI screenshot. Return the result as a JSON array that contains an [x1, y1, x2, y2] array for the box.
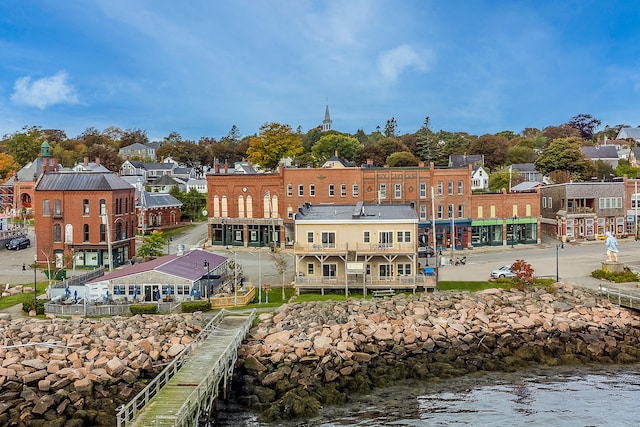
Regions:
[[0, 114, 638, 188]]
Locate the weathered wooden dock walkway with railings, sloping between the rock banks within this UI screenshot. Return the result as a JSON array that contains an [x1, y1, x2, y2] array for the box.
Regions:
[[118, 310, 256, 427]]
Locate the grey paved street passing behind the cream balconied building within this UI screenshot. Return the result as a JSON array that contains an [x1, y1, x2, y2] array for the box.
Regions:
[[0, 223, 640, 296]]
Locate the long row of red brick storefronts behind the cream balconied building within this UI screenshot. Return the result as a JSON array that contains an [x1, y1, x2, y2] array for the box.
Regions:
[[207, 160, 528, 248]]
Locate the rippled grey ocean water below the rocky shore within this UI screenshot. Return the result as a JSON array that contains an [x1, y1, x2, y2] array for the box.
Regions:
[[212, 365, 640, 427]]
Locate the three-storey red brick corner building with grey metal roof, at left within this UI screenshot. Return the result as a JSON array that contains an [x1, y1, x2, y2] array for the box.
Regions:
[[33, 172, 137, 267]]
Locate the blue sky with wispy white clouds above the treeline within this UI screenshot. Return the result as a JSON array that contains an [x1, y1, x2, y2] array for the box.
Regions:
[[0, 0, 640, 141]]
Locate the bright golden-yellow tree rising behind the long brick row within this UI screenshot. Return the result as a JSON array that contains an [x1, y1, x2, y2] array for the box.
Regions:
[[247, 123, 302, 170]]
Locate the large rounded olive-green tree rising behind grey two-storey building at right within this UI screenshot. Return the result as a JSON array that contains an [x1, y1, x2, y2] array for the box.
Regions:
[[534, 137, 588, 181]]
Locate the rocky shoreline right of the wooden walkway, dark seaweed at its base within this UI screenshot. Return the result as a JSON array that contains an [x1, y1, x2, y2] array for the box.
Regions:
[[234, 283, 640, 421]]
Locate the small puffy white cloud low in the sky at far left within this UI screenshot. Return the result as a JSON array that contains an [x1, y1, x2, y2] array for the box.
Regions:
[[11, 71, 78, 110]]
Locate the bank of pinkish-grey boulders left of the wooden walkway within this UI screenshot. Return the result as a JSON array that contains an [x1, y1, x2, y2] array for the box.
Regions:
[[0, 313, 211, 427]]
